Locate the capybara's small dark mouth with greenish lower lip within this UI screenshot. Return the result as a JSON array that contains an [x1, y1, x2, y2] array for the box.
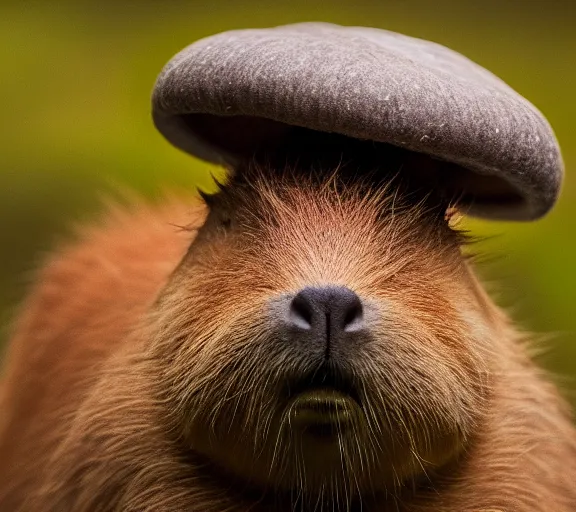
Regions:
[[287, 370, 361, 439]]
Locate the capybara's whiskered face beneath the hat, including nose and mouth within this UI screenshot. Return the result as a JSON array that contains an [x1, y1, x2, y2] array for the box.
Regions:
[[152, 165, 491, 500]]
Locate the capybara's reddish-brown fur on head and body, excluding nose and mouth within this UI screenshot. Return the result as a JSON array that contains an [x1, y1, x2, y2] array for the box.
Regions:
[[0, 165, 576, 512]]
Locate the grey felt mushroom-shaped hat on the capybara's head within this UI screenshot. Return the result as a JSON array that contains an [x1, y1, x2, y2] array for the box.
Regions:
[[152, 23, 563, 220]]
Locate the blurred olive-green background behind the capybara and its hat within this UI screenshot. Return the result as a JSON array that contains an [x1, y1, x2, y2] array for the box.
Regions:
[[0, 0, 576, 404]]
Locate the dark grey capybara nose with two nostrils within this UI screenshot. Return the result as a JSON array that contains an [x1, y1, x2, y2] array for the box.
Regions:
[[289, 286, 364, 344]]
